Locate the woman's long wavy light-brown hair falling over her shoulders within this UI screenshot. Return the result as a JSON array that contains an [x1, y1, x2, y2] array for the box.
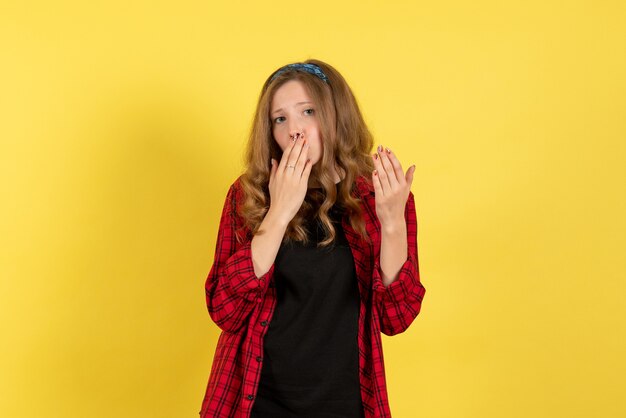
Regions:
[[239, 59, 374, 247]]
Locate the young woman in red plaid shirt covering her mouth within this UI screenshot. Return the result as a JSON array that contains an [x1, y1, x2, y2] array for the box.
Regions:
[[200, 59, 425, 418]]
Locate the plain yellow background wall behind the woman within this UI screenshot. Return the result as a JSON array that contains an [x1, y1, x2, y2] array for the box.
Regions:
[[0, 0, 626, 418]]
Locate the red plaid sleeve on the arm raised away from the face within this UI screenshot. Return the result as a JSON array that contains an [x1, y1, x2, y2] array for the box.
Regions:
[[372, 192, 426, 335]]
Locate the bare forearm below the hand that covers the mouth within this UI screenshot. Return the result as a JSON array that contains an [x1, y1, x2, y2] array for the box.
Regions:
[[250, 209, 288, 277]]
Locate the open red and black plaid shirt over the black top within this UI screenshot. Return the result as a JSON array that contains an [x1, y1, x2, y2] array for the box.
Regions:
[[200, 177, 426, 418]]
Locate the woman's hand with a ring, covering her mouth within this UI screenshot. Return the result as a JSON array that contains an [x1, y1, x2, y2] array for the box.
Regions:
[[268, 134, 312, 225]]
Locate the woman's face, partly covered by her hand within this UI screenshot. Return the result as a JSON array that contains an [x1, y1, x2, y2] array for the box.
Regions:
[[270, 80, 322, 164]]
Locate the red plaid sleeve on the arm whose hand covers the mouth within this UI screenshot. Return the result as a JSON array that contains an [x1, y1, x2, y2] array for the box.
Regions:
[[204, 185, 274, 332]]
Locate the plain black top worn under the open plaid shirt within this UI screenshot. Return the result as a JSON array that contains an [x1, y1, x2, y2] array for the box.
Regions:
[[251, 183, 364, 418]]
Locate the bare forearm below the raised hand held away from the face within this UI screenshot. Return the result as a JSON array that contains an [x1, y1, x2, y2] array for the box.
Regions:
[[380, 219, 408, 287]]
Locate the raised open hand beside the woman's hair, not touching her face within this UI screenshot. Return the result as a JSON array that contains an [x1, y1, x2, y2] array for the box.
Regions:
[[372, 145, 415, 230]]
